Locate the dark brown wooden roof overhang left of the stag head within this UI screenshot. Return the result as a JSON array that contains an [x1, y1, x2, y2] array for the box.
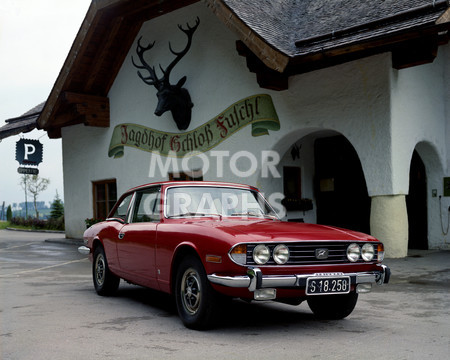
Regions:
[[38, 0, 198, 138]]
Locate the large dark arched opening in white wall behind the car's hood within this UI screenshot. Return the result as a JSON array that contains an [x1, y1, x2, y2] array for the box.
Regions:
[[272, 129, 371, 233]]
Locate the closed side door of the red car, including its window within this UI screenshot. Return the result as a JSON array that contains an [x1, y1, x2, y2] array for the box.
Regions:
[[117, 186, 160, 288]]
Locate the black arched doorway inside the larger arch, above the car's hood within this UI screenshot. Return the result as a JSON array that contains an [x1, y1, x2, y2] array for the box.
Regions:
[[314, 135, 370, 233]]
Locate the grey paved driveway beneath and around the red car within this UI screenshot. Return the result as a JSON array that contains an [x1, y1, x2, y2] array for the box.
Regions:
[[0, 230, 450, 360]]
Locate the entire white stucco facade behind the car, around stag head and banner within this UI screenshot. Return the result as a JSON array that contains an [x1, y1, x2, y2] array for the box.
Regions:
[[62, 3, 450, 258]]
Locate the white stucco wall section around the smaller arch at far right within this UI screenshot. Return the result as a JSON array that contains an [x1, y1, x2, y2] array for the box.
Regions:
[[391, 46, 450, 248]]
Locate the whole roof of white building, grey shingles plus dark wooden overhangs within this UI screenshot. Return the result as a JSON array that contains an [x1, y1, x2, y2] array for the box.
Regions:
[[38, 0, 450, 137]]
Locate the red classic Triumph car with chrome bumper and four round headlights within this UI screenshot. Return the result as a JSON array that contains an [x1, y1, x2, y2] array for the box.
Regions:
[[79, 181, 390, 329]]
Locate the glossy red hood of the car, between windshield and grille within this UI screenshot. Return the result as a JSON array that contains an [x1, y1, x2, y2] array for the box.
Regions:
[[187, 219, 376, 242]]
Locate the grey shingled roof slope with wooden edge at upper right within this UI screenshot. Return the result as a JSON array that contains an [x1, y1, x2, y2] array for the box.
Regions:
[[206, 0, 449, 74]]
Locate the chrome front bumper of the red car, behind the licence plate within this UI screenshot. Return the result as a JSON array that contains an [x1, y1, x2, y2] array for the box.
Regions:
[[208, 265, 391, 291]]
